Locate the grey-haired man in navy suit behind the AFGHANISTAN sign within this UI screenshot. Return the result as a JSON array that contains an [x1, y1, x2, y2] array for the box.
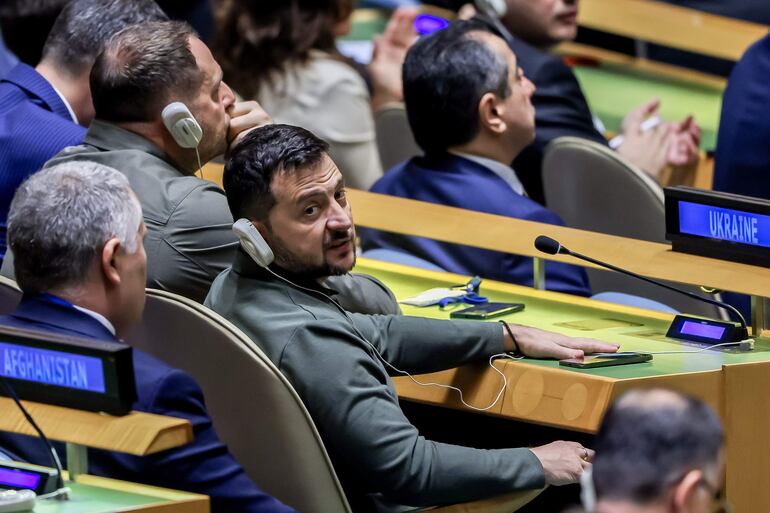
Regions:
[[0, 162, 293, 513]]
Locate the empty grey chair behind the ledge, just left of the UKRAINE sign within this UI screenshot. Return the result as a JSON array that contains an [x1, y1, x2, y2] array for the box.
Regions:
[[543, 137, 726, 318]]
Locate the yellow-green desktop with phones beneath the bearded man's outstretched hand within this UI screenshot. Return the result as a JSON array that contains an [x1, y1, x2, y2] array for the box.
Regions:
[[356, 259, 770, 379]]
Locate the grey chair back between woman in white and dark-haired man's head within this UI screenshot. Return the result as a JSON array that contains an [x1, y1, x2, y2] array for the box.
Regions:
[[374, 103, 422, 171]]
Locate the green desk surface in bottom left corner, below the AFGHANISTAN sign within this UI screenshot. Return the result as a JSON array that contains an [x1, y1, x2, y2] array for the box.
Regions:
[[34, 483, 165, 513]]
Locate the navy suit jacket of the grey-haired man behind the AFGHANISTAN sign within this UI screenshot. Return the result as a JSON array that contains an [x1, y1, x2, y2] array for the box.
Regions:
[[0, 295, 293, 513]]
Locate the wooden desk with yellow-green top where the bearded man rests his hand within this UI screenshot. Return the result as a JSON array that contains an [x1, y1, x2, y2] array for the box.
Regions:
[[356, 258, 770, 513]]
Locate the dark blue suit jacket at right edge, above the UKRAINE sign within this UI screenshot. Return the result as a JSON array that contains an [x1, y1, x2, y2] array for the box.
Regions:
[[714, 35, 770, 199]]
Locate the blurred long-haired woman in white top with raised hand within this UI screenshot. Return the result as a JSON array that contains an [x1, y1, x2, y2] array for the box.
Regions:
[[216, 0, 417, 189]]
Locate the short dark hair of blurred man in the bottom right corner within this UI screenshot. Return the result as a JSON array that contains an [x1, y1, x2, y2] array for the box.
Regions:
[[593, 390, 724, 504]]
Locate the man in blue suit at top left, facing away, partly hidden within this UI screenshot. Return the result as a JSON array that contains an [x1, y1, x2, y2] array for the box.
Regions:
[[0, 0, 166, 261]]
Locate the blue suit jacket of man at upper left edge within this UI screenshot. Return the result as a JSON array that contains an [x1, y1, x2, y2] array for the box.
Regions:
[[0, 64, 86, 260]]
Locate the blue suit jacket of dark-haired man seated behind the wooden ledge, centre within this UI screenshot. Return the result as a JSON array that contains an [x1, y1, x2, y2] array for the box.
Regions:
[[361, 154, 590, 296]]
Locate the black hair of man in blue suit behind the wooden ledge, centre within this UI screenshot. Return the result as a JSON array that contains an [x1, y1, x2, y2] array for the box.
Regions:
[[403, 20, 511, 153]]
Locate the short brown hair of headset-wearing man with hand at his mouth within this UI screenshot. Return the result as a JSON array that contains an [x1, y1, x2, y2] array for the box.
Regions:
[[91, 21, 203, 123]]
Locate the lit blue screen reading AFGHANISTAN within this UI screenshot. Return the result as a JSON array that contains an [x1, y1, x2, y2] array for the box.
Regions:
[[0, 342, 106, 393]]
